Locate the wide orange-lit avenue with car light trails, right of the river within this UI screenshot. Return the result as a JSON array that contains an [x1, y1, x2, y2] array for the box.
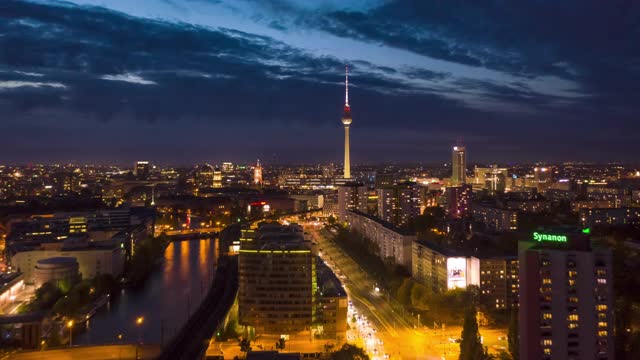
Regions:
[[305, 222, 506, 359]]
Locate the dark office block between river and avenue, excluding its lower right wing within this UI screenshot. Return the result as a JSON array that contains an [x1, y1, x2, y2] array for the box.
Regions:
[[238, 223, 317, 335]]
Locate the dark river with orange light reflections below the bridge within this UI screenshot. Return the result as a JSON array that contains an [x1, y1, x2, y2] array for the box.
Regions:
[[73, 239, 219, 345]]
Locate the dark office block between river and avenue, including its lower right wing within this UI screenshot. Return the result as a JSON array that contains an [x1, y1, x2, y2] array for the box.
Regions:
[[238, 223, 348, 340]]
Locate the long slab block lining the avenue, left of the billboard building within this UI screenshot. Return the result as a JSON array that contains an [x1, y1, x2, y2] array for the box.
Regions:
[[346, 210, 416, 269]]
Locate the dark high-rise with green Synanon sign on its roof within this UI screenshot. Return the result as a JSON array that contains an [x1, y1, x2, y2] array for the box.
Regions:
[[518, 228, 614, 360]]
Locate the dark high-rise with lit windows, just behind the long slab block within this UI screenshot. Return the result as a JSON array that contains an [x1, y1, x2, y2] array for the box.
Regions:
[[376, 182, 421, 226]]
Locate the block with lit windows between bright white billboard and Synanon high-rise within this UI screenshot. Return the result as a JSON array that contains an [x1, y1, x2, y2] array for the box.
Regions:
[[480, 256, 519, 309]]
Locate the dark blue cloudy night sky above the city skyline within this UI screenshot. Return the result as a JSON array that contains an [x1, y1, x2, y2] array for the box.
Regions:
[[0, 0, 640, 164]]
